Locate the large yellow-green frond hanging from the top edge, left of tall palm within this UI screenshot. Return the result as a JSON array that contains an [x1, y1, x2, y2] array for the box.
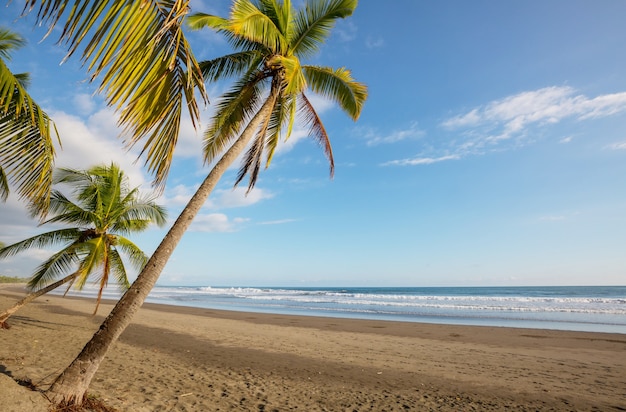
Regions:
[[24, 0, 208, 185]]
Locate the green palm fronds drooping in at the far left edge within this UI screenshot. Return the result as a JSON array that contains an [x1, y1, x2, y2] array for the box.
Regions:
[[0, 27, 55, 216]]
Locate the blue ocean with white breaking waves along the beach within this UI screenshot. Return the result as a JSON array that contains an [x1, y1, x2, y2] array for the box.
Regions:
[[57, 286, 626, 334]]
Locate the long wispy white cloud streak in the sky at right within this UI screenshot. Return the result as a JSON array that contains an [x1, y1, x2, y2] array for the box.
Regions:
[[382, 86, 626, 166]]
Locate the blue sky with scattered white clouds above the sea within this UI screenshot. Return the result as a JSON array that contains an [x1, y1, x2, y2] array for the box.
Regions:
[[0, 0, 626, 286]]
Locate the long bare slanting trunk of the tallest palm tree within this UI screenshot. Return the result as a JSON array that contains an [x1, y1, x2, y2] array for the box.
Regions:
[[47, 87, 278, 405]]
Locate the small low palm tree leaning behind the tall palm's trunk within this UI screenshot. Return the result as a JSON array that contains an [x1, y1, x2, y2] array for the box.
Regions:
[[0, 164, 166, 328]]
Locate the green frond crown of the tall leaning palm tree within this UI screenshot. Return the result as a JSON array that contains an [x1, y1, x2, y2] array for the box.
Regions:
[[187, 0, 367, 190]]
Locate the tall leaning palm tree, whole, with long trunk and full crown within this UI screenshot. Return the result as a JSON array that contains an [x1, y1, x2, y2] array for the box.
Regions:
[[48, 0, 367, 404]]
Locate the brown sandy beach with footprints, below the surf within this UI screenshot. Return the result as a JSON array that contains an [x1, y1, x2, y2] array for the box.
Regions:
[[0, 285, 626, 412]]
